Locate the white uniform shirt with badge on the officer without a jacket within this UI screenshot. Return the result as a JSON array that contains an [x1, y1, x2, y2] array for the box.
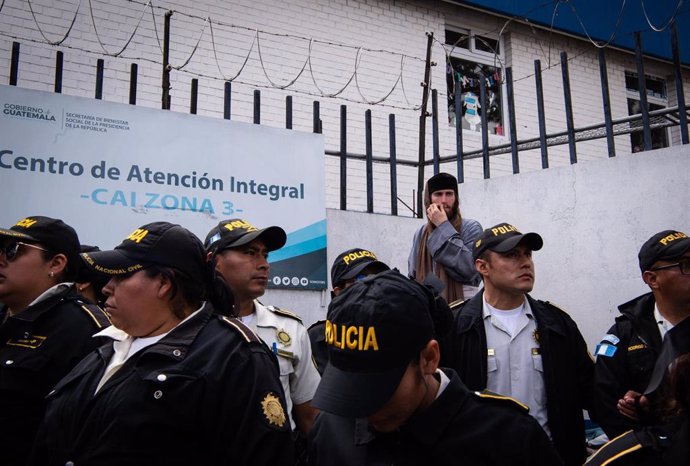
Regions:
[[243, 300, 321, 429]]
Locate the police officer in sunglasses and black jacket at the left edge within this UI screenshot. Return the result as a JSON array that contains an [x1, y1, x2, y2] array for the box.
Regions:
[[0, 216, 110, 465]]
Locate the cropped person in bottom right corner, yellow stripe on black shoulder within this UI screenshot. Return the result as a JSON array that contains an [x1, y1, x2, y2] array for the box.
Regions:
[[586, 318, 690, 466]]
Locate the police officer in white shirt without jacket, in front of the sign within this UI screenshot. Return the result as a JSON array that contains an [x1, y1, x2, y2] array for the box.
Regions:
[[204, 218, 320, 434]]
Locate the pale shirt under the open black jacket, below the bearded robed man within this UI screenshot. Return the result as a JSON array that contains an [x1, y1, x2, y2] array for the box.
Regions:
[[483, 299, 551, 436]]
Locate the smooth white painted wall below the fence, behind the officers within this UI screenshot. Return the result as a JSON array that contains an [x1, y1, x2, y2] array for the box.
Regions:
[[266, 146, 690, 349]]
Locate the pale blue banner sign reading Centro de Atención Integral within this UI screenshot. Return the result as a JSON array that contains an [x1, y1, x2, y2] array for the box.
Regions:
[[0, 85, 327, 289]]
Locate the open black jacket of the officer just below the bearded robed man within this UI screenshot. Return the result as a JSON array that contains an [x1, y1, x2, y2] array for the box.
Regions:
[[446, 290, 594, 465]]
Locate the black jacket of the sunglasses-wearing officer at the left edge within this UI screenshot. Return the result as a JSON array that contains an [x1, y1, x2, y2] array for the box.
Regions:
[[0, 285, 110, 466]]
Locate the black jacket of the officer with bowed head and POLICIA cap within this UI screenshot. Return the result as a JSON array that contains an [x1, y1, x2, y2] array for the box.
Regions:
[[309, 369, 563, 466]]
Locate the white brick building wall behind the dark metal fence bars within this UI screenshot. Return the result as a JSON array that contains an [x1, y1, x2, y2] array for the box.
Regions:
[[0, 0, 690, 215]]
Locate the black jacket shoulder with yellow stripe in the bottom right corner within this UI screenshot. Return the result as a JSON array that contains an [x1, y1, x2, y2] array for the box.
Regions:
[[585, 417, 690, 466]]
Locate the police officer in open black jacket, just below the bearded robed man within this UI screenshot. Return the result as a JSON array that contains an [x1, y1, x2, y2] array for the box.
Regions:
[[448, 223, 594, 465]]
